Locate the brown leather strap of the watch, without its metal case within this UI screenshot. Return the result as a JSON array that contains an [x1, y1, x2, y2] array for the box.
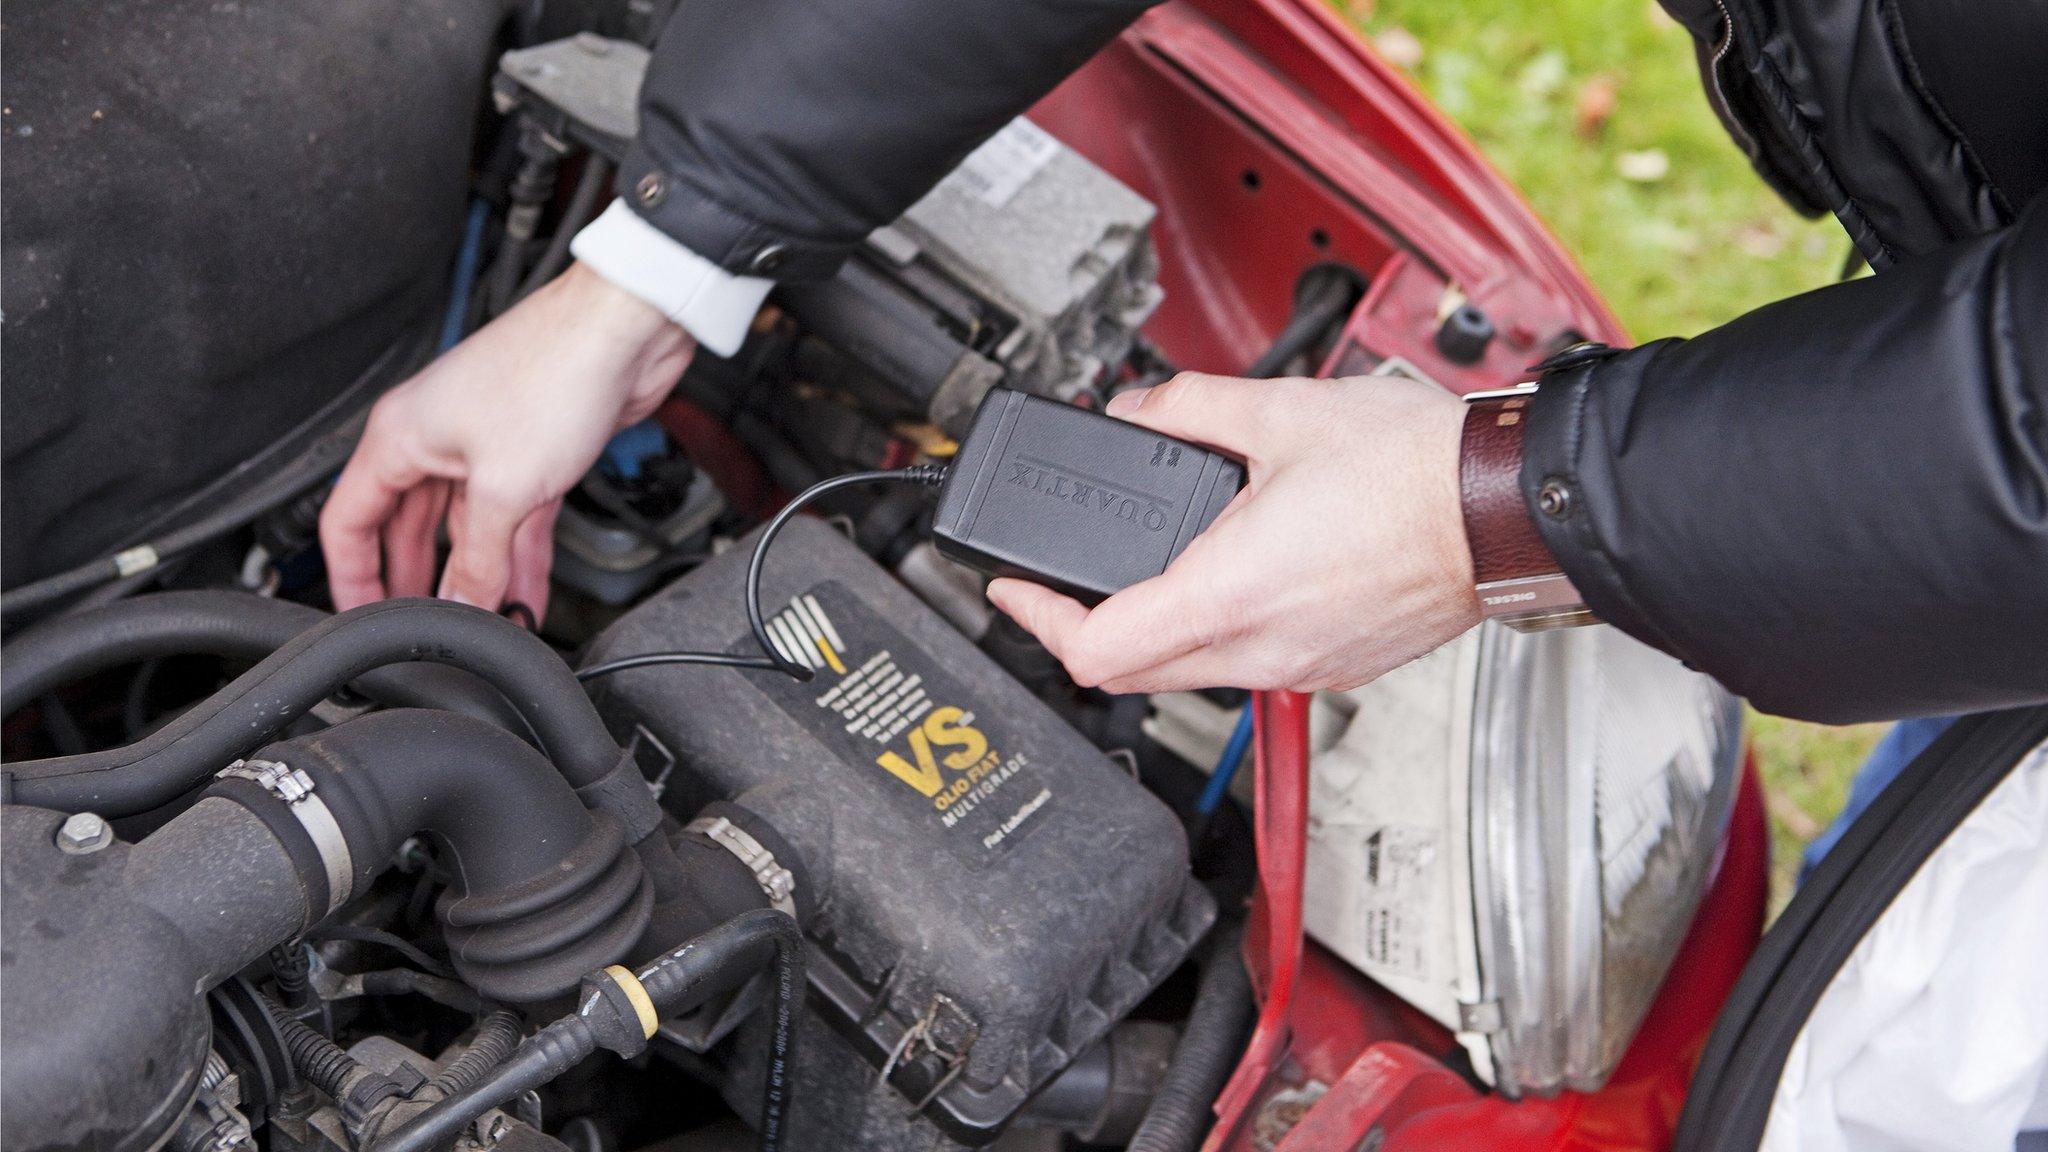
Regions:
[[1458, 394, 1559, 584]]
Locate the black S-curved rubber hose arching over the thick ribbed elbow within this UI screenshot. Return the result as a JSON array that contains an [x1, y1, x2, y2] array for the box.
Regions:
[[4, 601, 623, 816]]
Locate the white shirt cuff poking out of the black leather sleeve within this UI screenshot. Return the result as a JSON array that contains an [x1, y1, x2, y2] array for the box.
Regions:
[[569, 201, 774, 357]]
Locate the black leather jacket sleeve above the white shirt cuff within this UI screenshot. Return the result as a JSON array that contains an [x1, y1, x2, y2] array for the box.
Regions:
[[618, 0, 1155, 281]]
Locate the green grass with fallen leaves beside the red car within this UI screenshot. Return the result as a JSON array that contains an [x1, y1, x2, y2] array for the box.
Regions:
[[1339, 0, 1882, 914]]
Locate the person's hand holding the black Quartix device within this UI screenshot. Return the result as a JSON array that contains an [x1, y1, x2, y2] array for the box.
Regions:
[[989, 373, 1479, 693]]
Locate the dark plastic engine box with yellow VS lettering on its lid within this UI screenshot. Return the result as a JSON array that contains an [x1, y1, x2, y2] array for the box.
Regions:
[[592, 519, 1214, 1148]]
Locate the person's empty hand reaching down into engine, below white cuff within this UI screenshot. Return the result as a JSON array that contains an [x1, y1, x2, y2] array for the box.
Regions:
[[319, 264, 696, 619]]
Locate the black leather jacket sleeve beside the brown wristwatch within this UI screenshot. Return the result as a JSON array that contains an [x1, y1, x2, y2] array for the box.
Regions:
[[1522, 197, 2048, 724]]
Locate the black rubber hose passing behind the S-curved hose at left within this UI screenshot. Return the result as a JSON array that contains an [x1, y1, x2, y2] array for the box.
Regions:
[[0, 590, 528, 734]]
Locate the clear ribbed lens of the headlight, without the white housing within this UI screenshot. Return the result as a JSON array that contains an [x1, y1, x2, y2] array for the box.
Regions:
[[1468, 625, 1743, 1095]]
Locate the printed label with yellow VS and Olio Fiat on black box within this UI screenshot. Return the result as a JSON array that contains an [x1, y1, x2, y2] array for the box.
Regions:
[[729, 580, 1055, 867]]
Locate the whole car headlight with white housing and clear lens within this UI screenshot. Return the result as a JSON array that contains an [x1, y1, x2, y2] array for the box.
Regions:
[[1305, 623, 1743, 1095]]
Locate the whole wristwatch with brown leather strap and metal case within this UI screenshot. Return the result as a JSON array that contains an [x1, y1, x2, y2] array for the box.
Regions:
[[1458, 383, 1595, 631]]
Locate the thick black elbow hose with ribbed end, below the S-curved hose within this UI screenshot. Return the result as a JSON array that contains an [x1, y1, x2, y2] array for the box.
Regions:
[[238, 709, 653, 1004]]
